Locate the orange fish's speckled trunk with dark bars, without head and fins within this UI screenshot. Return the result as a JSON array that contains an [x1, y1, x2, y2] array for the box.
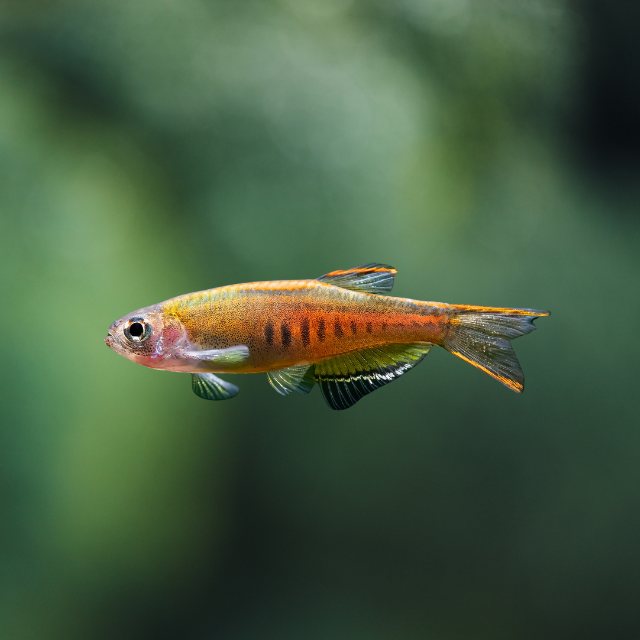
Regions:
[[162, 280, 448, 373]]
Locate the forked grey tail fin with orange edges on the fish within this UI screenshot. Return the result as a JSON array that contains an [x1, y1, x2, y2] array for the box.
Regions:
[[441, 305, 549, 393]]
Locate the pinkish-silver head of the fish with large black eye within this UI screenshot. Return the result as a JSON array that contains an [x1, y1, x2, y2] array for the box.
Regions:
[[104, 305, 186, 369]]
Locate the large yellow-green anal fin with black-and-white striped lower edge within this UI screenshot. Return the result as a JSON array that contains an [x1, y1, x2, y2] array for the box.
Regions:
[[314, 342, 432, 409]]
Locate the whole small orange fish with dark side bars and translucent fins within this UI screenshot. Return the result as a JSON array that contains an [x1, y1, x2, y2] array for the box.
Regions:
[[104, 263, 550, 410]]
